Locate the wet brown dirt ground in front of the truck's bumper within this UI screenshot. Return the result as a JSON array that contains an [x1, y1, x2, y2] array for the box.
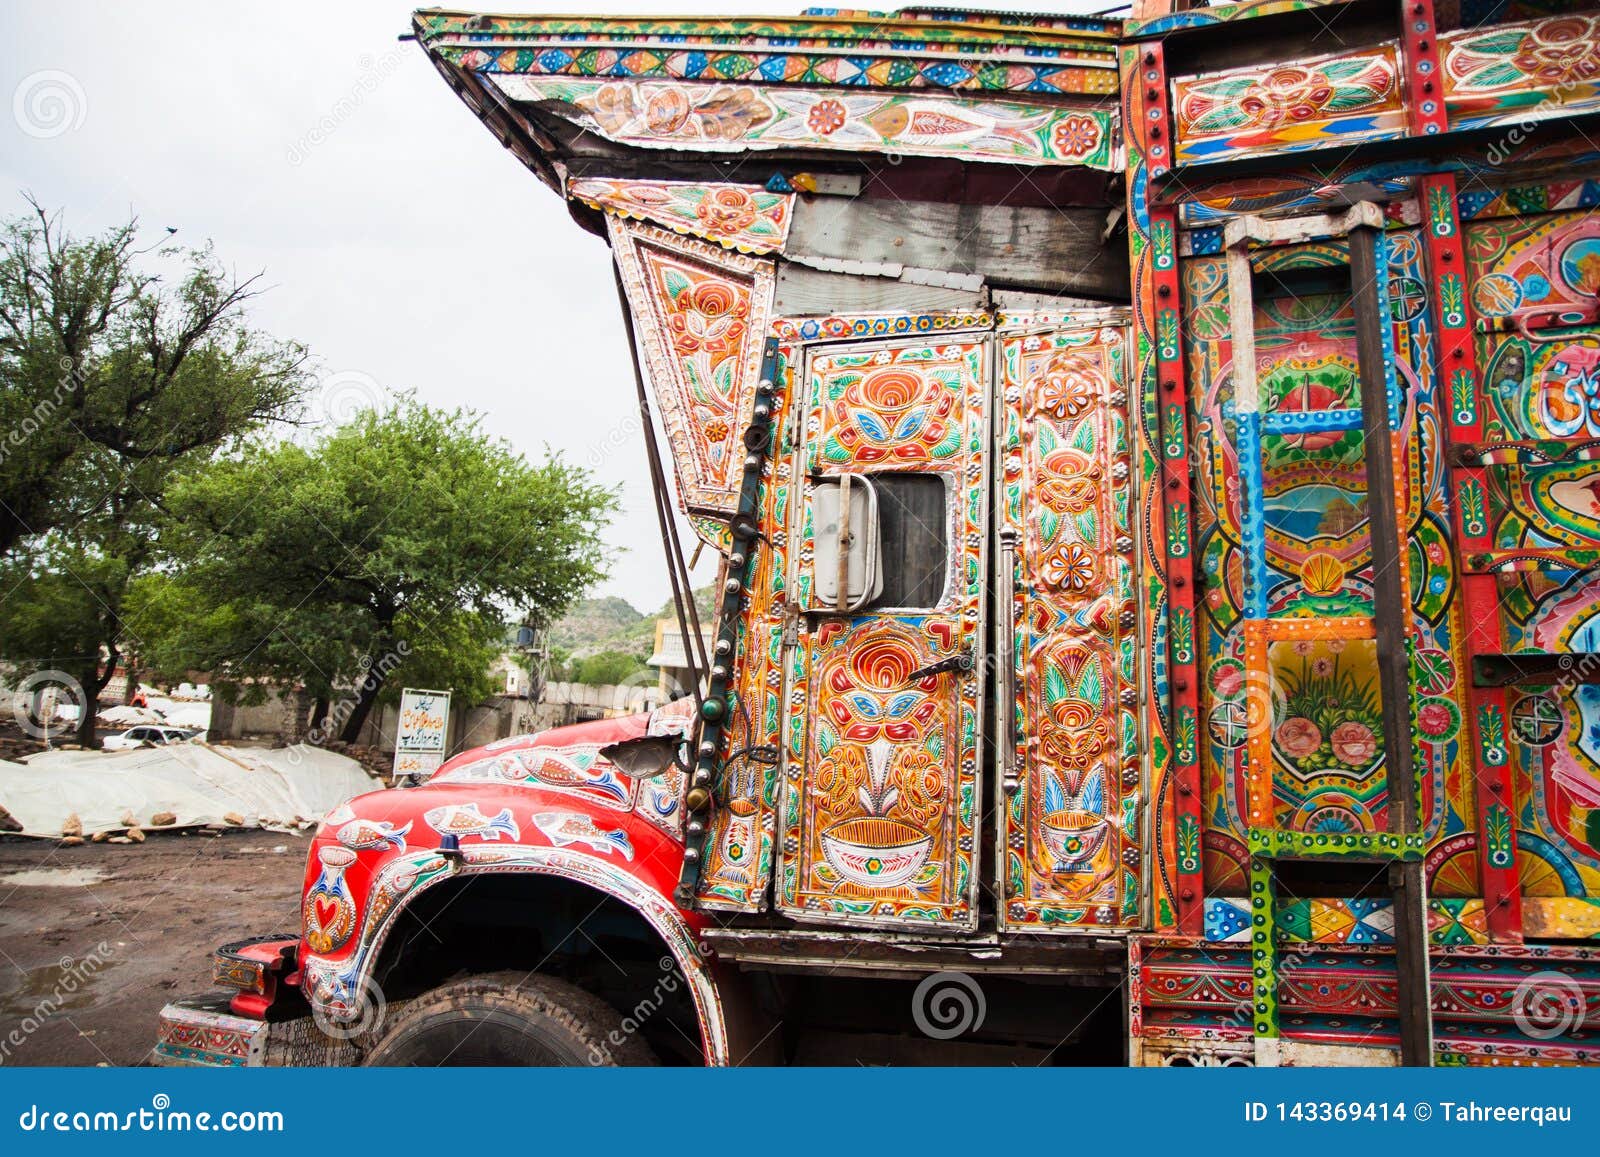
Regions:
[[0, 831, 307, 1064]]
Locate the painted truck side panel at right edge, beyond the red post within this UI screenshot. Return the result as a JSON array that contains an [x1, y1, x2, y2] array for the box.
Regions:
[[1458, 210, 1600, 902]]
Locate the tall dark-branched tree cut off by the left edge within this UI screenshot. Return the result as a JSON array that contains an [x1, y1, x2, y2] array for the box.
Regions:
[[0, 203, 309, 746]]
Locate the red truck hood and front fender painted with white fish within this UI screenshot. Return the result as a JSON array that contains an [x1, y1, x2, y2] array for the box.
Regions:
[[299, 704, 728, 1064]]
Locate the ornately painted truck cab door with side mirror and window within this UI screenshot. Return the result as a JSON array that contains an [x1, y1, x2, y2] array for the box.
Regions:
[[778, 334, 992, 928]]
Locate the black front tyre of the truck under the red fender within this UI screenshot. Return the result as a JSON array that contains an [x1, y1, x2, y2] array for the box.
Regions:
[[365, 971, 656, 1067]]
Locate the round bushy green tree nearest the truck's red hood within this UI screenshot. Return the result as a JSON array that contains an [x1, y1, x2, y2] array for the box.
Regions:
[[136, 398, 616, 741]]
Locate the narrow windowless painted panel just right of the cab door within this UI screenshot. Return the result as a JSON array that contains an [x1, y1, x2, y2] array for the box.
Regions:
[[997, 323, 1142, 931]]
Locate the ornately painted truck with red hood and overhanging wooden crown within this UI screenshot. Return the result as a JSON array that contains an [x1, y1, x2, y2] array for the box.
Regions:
[[155, 0, 1600, 1066]]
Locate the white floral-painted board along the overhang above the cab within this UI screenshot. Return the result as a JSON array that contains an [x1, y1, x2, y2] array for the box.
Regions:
[[491, 74, 1115, 170]]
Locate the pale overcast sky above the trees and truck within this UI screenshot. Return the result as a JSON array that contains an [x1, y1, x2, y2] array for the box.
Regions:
[[0, 0, 1109, 611]]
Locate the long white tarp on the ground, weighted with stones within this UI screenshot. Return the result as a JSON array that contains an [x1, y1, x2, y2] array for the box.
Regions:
[[0, 743, 382, 835]]
